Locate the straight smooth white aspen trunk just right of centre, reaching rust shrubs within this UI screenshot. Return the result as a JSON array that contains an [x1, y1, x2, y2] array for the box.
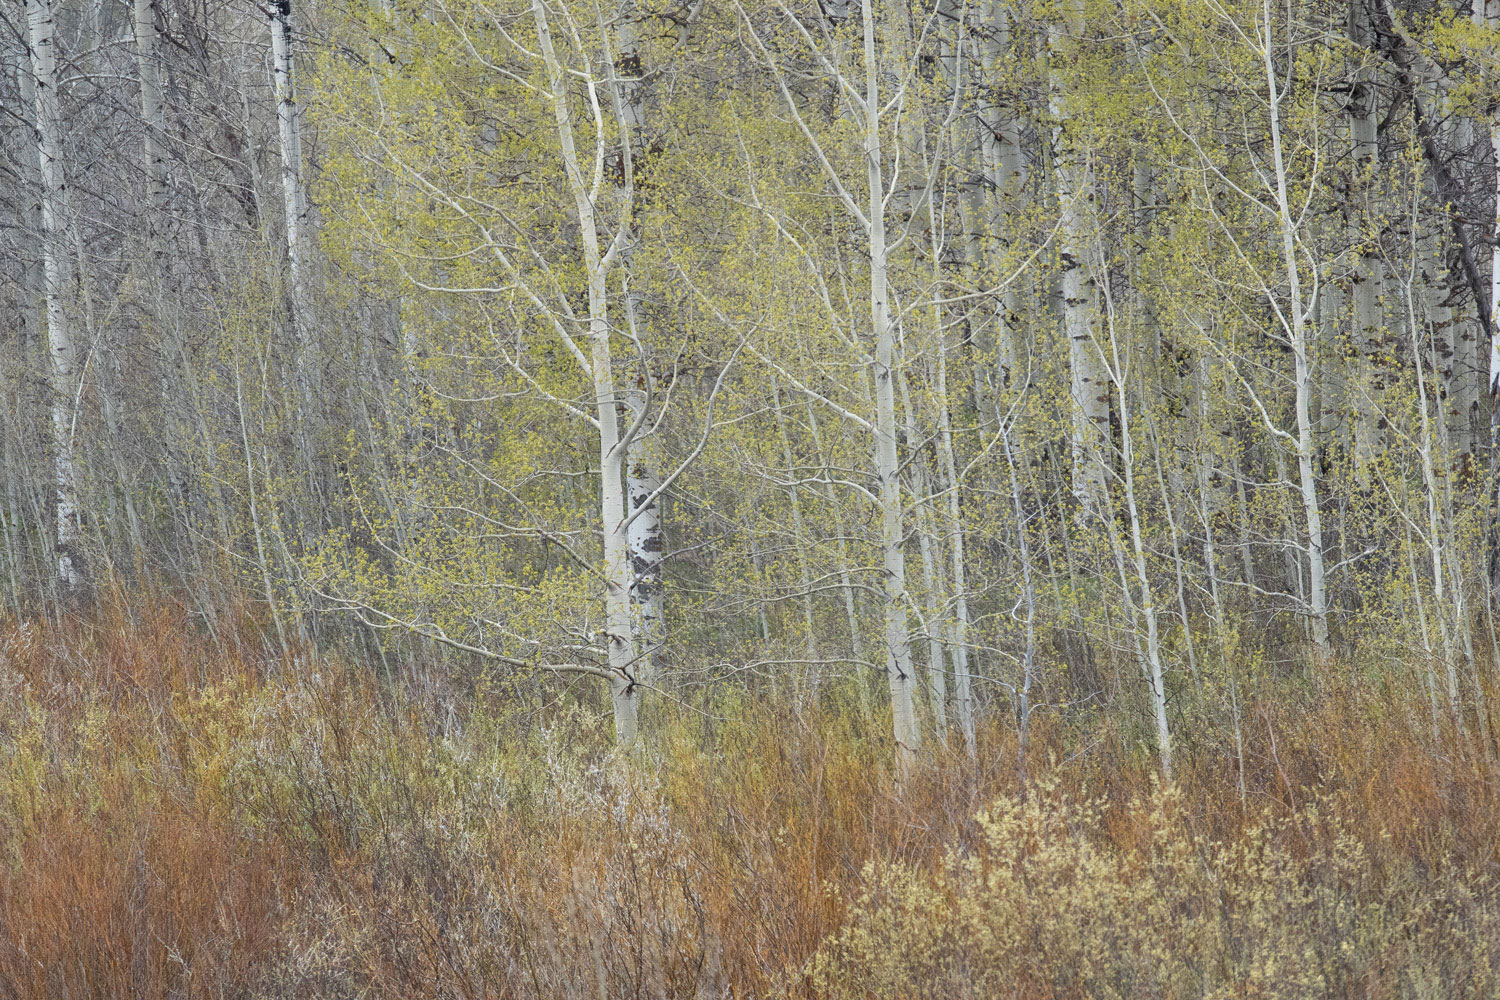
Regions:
[[860, 0, 921, 784]]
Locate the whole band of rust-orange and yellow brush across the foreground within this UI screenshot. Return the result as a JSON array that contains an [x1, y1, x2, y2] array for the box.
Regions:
[[0, 587, 1500, 999]]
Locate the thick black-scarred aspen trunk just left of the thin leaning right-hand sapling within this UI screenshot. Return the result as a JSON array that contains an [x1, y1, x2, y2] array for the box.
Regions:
[[1047, 0, 1110, 517]]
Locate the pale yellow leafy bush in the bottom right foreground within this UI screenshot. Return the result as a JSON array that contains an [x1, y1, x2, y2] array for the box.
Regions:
[[809, 783, 1500, 1000]]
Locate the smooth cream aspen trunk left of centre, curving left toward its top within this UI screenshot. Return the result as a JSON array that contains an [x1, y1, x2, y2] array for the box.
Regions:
[[531, 0, 639, 747]]
